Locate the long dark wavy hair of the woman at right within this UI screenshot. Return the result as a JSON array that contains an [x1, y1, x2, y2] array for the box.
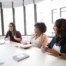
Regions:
[[55, 18, 66, 45]]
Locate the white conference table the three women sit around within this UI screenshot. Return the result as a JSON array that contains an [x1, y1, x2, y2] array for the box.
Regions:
[[0, 42, 66, 66]]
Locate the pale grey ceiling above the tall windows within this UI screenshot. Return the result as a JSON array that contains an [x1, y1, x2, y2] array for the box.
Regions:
[[0, 0, 43, 8]]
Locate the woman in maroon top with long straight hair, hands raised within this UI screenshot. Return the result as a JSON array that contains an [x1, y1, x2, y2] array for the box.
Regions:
[[5, 23, 22, 43]]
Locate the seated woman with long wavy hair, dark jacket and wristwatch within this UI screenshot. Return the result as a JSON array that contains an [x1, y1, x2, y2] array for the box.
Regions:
[[42, 19, 66, 59]]
